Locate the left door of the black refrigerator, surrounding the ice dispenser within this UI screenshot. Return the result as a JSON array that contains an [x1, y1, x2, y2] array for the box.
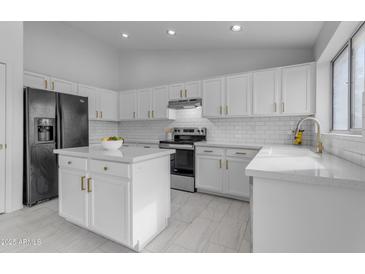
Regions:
[[23, 88, 58, 206]]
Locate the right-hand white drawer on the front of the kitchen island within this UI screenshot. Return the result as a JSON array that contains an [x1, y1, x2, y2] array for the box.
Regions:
[[89, 160, 130, 178]]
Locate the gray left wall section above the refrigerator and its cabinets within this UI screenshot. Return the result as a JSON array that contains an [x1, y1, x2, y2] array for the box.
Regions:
[[24, 22, 119, 89]]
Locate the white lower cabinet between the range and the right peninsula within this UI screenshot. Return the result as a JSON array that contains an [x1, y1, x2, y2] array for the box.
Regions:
[[195, 147, 257, 200]]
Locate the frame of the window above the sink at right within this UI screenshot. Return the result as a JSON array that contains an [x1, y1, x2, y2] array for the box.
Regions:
[[331, 22, 365, 135]]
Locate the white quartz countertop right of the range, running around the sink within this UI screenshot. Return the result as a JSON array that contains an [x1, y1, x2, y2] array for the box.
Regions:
[[195, 141, 365, 189]]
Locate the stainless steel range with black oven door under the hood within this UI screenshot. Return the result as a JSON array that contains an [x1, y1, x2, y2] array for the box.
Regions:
[[160, 128, 207, 192]]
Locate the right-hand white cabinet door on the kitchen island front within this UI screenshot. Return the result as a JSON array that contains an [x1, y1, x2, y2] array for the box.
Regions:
[[89, 174, 130, 244]]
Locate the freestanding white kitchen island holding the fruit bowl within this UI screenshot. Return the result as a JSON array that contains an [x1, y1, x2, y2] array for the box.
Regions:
[[54, 146, 175, 251]]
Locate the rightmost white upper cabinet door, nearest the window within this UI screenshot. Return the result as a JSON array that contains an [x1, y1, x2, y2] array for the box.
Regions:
[[281, 65, 311, 114]]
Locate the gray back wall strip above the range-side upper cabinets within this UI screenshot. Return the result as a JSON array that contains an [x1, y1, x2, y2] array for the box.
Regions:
[[120, 49, 314, 90]]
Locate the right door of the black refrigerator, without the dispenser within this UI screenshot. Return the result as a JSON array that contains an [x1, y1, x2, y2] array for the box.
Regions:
[[58, 93, 89, 148]]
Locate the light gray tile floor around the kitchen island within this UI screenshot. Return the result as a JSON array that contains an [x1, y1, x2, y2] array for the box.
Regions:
[[0, 190, 250, 253]]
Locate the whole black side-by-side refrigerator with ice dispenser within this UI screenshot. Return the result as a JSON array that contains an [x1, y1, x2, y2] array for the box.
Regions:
[[23, 87, 89, 206]]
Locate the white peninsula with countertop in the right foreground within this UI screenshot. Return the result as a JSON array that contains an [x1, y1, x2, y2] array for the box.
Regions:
[[246, 145, 365, 252]]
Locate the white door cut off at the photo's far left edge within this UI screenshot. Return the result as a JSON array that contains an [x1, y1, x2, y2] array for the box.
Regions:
[[0, 63, 6, 213]]
